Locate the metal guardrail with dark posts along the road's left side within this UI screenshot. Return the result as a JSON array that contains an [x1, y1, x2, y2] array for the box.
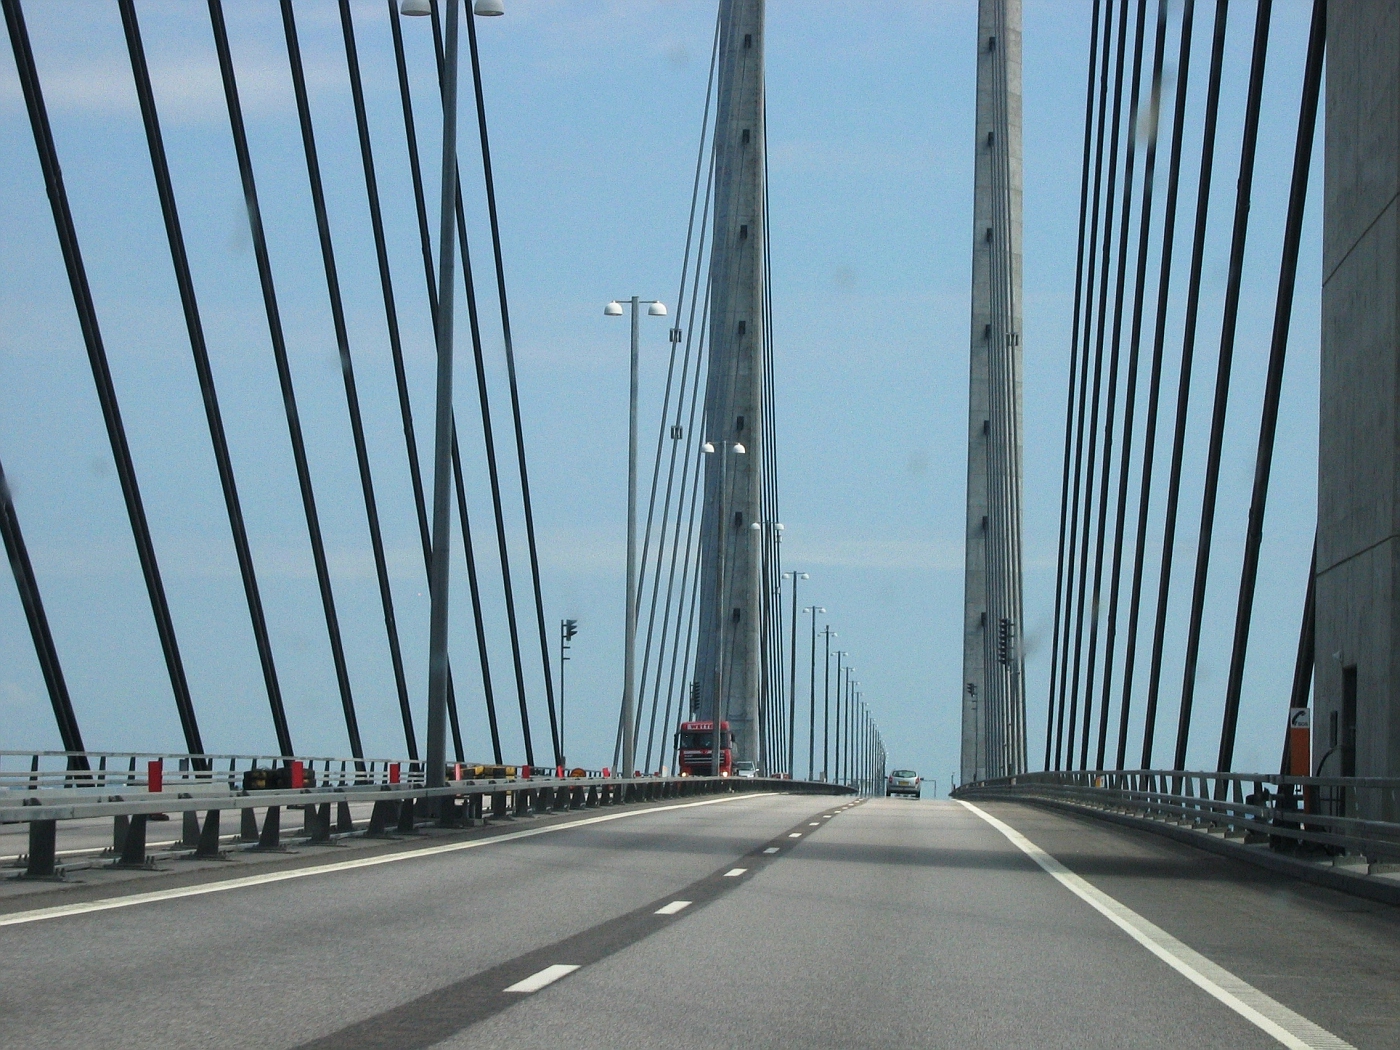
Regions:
[[0, 752, 850, 879]]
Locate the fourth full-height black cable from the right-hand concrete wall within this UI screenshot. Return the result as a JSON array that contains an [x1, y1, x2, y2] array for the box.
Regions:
[[1116, 0, 1196, 769]]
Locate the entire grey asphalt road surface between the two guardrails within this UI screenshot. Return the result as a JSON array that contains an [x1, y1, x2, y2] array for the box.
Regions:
[[0, 795, 1400, 1050]]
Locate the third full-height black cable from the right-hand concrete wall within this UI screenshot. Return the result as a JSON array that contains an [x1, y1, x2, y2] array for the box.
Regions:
[[1141, 0, 1229, 769]]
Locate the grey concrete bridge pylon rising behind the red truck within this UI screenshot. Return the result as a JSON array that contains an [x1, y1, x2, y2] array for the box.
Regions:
[[692, 0, 769, 762]]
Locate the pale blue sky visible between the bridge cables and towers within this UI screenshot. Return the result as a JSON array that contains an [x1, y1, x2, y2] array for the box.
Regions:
[[0, 0, 1322, 787]]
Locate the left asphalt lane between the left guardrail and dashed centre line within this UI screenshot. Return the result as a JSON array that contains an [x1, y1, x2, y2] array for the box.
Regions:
[[0, 795, 832, 1050]]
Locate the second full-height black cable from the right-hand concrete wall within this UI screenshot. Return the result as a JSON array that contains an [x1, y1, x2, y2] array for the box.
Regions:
[[1173, 0, 1273, 769]]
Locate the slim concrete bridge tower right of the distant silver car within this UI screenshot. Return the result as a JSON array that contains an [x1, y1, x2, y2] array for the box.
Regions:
[[962, 0, 1026, 783]]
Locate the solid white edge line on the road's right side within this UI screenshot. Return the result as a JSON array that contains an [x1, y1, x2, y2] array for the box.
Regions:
[[958, 798, 1355, 1050]]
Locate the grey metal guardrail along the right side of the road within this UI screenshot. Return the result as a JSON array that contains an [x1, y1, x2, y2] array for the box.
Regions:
[[953, 770, 1400, 869]]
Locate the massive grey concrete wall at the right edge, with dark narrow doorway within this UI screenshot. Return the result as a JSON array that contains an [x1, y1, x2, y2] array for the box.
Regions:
[[1313, 0, 1400, 776]]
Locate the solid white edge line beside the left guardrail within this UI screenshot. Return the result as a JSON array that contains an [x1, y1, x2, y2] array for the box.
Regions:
[[0, 794, 777, 927]]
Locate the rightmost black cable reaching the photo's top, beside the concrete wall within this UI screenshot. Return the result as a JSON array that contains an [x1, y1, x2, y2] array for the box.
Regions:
[[1217, 0, 1327, 790]]
